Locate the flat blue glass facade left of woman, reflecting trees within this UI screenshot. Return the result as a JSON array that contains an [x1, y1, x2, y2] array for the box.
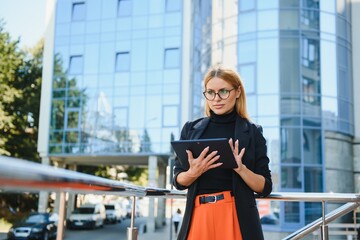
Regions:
[[49, 0, 182, 155]]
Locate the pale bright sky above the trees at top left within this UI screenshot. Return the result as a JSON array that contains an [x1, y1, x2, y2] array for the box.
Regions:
[[0, 0, 47, 48]]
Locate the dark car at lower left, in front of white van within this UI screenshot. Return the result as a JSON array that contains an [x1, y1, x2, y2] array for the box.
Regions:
[[8, 213, 57, 240]]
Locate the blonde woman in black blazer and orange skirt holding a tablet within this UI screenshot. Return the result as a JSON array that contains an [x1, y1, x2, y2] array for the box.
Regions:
[[173, 66, 272, 240]]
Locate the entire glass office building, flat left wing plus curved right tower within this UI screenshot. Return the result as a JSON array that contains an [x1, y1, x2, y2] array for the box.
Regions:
[[42, 0, 354, 236]]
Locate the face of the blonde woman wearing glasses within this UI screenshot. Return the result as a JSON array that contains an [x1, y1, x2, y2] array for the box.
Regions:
[[205, 77, 241, 115]]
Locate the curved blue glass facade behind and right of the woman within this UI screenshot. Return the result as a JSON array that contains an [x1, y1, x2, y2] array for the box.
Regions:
[[192, 0, 354, 229]]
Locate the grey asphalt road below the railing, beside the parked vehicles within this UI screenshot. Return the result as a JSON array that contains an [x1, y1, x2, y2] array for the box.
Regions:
[[64, 217, 146, 240]]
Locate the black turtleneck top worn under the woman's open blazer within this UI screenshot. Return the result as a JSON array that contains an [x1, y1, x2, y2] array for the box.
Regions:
[[197, 111, 237, 194]]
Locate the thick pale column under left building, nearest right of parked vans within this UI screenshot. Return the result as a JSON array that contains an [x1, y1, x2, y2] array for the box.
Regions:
[[146, 156, 158, 232]]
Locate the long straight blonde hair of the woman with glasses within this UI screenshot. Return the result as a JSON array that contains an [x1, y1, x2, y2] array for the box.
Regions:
[[204, 65, 250, 120]]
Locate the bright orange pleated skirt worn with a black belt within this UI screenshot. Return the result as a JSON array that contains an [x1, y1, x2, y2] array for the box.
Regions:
[[187, 191, 242, 240]]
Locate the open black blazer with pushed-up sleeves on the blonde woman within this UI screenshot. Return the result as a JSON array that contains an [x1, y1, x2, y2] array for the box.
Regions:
[[173, 116, 272, 240]]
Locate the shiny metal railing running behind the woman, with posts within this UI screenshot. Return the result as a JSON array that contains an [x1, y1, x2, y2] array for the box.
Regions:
[[0, 156, 360, 240]]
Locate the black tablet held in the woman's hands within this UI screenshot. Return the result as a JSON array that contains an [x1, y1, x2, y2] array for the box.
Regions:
[[171, 138, 237, 169]]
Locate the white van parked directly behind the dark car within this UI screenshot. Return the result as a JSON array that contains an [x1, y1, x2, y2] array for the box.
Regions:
[[66, 203, 106, 229]]
